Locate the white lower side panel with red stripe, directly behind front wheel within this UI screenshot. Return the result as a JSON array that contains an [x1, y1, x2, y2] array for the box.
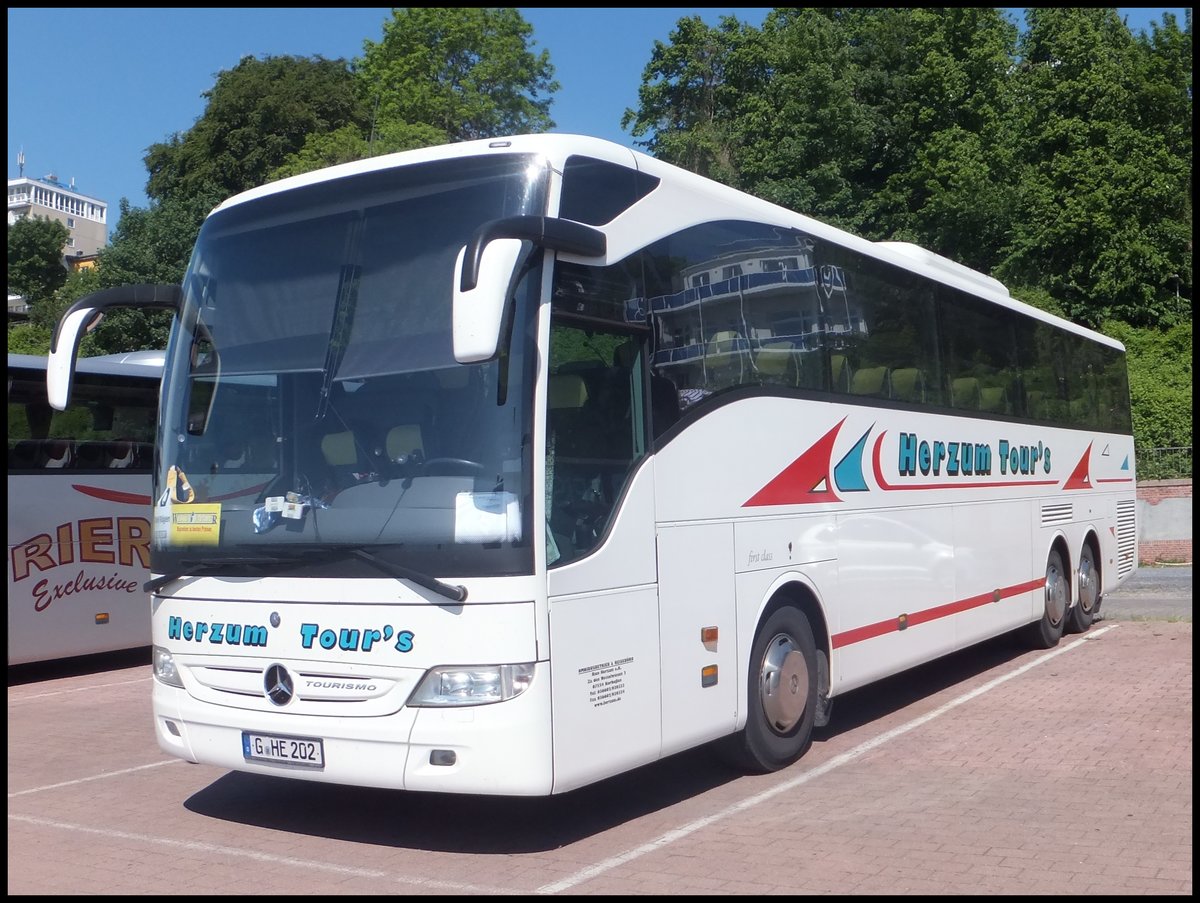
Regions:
[[833, 507, 955, 689]]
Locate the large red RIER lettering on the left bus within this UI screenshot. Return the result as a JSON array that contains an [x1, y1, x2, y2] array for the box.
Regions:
[[8, 518, 150, 582]]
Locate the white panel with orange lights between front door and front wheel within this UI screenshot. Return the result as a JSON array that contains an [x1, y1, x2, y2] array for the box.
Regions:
[[659, 524, 742, 755]]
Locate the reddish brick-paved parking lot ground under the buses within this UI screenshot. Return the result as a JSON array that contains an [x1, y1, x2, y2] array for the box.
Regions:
[[7, 610, 1193, 896]]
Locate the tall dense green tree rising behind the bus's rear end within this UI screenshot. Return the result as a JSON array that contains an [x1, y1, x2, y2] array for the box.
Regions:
[[997, 7, 1192, 327]]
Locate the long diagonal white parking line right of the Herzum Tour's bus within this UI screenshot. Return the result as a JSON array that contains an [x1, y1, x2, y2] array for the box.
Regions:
[[535, 623, 1117, 893]]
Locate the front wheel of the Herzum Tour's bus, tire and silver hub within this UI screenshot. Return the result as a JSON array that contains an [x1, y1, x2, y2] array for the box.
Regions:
[[722, 605, 820, 775]]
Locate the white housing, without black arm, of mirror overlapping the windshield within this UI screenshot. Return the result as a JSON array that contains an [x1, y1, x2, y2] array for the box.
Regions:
[[451, 238, 521, 364]]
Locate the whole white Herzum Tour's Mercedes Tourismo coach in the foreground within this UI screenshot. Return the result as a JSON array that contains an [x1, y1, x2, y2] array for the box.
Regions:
[[48, 134, 1136, 795]]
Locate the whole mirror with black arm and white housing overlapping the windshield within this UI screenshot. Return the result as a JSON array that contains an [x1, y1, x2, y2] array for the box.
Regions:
[[451, 216, 608, 364]]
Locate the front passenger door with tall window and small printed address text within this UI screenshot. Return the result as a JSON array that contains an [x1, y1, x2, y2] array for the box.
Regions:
[[546, 329, 661, 793]]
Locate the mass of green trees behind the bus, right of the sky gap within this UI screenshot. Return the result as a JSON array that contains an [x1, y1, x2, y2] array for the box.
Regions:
[[622, 7, 1193, 465]]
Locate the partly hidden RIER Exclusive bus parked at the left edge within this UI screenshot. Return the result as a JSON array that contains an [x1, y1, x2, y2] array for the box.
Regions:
[[8, 352, 163, 665]]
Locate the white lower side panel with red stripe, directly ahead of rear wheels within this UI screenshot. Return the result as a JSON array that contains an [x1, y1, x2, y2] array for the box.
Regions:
[[954, 501, 1042, 648]]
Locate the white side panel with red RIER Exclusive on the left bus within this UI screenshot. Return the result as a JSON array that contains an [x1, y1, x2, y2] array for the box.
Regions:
[[8, 472, 150, 665]]
